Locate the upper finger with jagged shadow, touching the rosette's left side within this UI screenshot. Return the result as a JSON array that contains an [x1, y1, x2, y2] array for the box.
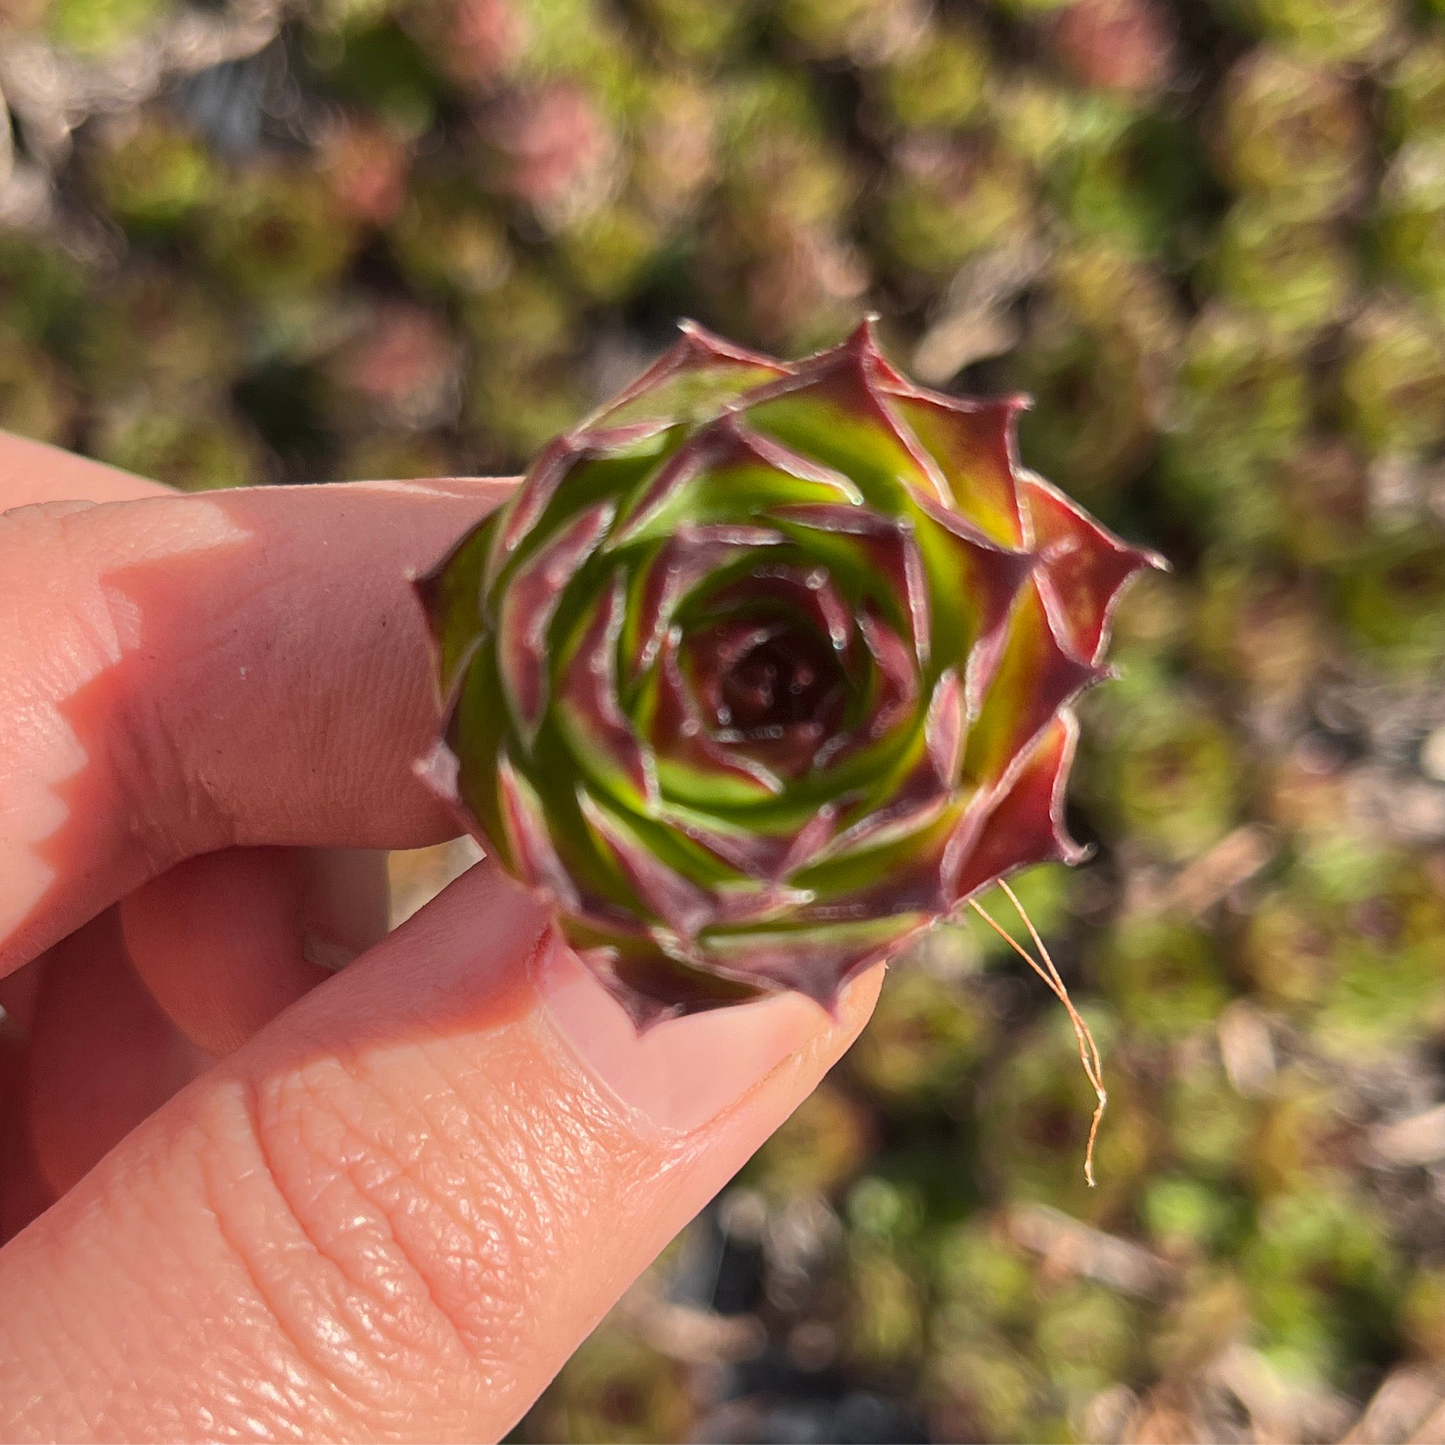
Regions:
[[0, 481, 507, 972]]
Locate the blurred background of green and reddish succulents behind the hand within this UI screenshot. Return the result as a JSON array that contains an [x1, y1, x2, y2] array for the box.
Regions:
[[0, 0, 1445, 1445]]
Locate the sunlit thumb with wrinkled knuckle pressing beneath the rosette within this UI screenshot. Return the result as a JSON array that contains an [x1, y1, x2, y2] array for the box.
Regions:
[[0, 863, 879, 1445]]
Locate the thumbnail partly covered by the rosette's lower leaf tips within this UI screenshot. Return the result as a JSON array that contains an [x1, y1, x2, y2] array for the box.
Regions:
[[533, 942, 847, 1133]]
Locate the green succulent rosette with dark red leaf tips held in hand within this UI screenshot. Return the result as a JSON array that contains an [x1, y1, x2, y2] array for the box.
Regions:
[[420, 324, 1157, 1025]]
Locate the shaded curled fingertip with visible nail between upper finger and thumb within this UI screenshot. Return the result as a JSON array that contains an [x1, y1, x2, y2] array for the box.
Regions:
[[120, 848, 387, 1058]]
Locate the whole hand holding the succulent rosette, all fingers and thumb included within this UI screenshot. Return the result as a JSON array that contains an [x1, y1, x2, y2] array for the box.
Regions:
[[0, 436, 880, 1445]]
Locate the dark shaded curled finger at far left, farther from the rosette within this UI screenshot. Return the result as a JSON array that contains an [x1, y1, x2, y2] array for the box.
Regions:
[[25, 910, 210, 1195]]
